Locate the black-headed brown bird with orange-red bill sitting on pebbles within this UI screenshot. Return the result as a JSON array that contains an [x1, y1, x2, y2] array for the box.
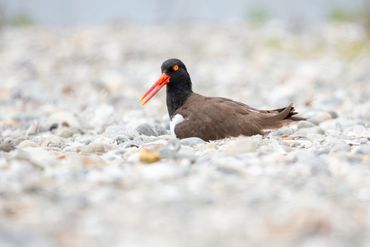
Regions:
[[140, 58, 304, 142]]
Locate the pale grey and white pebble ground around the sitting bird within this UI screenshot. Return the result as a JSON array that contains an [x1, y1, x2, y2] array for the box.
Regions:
[[0, 22, 370, 247]]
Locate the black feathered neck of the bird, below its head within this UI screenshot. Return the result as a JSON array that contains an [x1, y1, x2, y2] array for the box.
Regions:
[[167, 78, 193, 119]]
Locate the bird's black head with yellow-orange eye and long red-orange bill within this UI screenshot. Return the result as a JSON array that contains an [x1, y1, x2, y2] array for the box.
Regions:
[[140, 58, 191, 105]]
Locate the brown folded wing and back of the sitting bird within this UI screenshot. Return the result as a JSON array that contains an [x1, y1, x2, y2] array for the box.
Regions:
[[175, 94, 304, 141]]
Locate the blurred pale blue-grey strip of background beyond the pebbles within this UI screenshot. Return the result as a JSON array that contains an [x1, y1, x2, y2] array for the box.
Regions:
[[0, 0, 369, 26]]
